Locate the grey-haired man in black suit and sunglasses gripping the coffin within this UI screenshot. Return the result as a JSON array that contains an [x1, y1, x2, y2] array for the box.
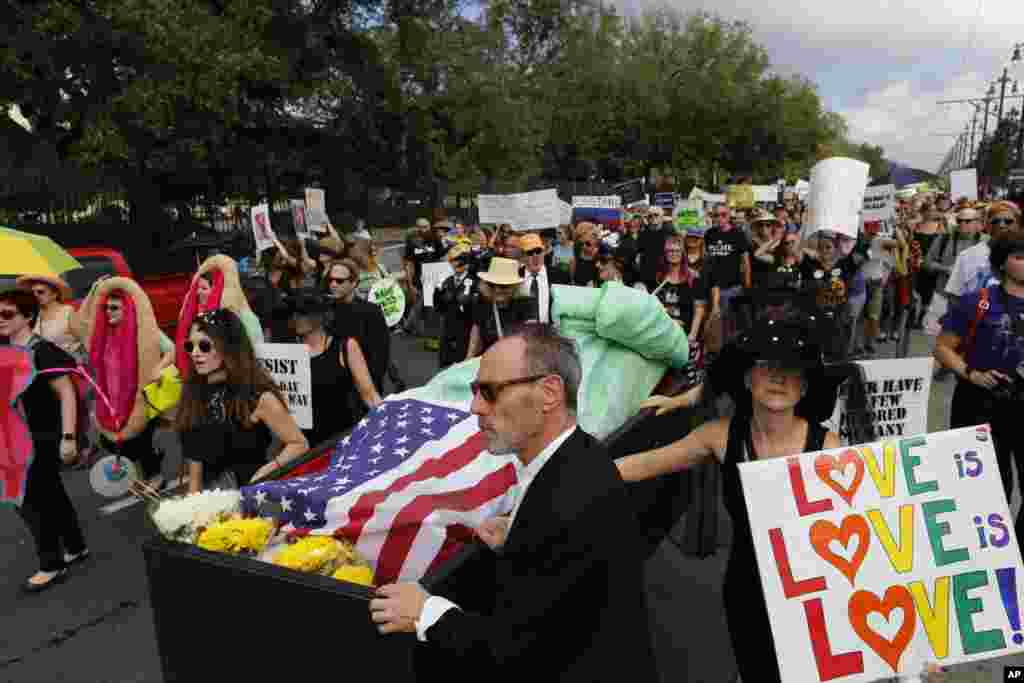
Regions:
[[370, 325, 657, 683]]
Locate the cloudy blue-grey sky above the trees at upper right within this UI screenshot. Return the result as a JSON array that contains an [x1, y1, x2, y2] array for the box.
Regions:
[[614, 0, 1024, 171]]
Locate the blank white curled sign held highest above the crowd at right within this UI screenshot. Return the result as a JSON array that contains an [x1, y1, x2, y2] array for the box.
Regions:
[[803, 157, 870, 239]]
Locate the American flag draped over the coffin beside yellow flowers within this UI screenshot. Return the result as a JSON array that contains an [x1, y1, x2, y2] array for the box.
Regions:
[[242, 397, 516, 585]]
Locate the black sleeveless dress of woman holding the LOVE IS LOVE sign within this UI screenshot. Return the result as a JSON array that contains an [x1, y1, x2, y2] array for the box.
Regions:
[[722, 415, 828, 683]]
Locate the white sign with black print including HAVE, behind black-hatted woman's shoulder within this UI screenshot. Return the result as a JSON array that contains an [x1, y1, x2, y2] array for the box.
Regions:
[[825, 356, 934, 443]]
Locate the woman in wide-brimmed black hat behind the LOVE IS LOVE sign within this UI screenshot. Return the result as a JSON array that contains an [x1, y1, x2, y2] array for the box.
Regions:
[[615, 310, 872, 681]]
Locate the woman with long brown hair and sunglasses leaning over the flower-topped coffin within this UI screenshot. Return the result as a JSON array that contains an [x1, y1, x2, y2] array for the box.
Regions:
[[174, 309, 309, 493]]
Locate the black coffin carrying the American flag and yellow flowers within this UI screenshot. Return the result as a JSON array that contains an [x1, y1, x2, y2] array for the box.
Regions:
[[142, 374, 689, 683]]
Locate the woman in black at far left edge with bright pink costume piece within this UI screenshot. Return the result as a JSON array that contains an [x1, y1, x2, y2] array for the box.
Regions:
[[0, 290, 89, 593]]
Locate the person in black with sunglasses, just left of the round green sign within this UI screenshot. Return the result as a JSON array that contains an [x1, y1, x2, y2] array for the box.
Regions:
[[324, 258, 391, 391]]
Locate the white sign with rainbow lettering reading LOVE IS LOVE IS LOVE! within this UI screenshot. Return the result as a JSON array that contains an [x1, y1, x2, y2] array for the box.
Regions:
[[739, 426, 1024, 683]]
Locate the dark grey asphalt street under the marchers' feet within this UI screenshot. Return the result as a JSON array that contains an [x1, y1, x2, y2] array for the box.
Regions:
[[0, 268, 1019, 683]]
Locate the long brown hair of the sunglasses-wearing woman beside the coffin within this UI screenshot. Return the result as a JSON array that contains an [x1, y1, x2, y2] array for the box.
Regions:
[[174, 308, 288, 432]]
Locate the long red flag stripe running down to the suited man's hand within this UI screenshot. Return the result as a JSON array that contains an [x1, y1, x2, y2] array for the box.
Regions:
[[376, 463, 516, 586]]
